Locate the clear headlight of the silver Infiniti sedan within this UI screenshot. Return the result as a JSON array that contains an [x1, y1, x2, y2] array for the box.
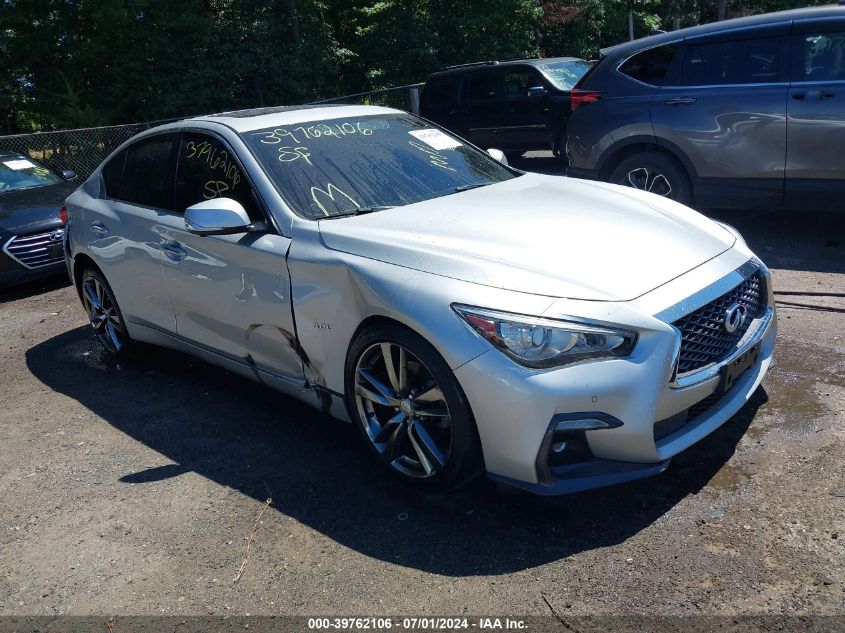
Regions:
[[452, 304, 637, 368]]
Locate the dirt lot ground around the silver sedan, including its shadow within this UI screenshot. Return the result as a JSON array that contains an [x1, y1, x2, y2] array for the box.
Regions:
[[0, 158, 845, 617]]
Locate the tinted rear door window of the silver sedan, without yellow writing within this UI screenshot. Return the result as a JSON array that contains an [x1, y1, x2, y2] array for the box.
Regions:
[[115, 134, 179, 211]]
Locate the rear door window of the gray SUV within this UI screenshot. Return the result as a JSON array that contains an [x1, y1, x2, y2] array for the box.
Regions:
[[683, 37, 781, 86]]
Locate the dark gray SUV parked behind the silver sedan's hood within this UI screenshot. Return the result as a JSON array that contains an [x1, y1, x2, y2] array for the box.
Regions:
[[566, 6, 845, 209]]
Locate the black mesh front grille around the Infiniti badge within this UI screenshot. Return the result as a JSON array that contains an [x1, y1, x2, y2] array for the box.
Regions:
[[673, 273, 763, 375]]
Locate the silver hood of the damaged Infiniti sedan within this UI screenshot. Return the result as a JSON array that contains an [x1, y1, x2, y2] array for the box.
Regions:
[[320, 174, 735, 301]]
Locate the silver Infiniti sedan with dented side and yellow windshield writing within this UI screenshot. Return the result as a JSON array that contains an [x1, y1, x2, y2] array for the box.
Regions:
[[65, 106, 775, 494]]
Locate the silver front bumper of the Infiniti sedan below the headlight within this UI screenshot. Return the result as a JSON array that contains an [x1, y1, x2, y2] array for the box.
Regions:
[[456, 256, 776, 495]]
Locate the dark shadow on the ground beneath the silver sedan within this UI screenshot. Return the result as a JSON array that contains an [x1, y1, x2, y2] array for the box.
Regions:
[[26, 327, 766, 576]]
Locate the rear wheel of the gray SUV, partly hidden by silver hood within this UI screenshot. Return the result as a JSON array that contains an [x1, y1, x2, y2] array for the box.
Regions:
[[608, 152, 693, 205]]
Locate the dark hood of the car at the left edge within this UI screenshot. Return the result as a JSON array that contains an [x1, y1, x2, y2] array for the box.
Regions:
[[0, 182, 78, 233]]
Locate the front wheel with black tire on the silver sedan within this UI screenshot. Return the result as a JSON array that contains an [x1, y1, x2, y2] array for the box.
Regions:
[[346, 325, 481, 492]]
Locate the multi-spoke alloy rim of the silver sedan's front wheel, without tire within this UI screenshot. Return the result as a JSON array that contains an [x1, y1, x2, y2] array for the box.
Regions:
[[355, 342, 452, 478]]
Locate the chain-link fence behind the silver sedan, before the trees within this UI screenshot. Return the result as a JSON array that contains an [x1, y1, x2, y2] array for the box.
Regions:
[[0, 84, 423, 180]]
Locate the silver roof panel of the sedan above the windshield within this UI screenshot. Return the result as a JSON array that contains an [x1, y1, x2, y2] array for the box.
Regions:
[[187, 104, 400, 133]]
